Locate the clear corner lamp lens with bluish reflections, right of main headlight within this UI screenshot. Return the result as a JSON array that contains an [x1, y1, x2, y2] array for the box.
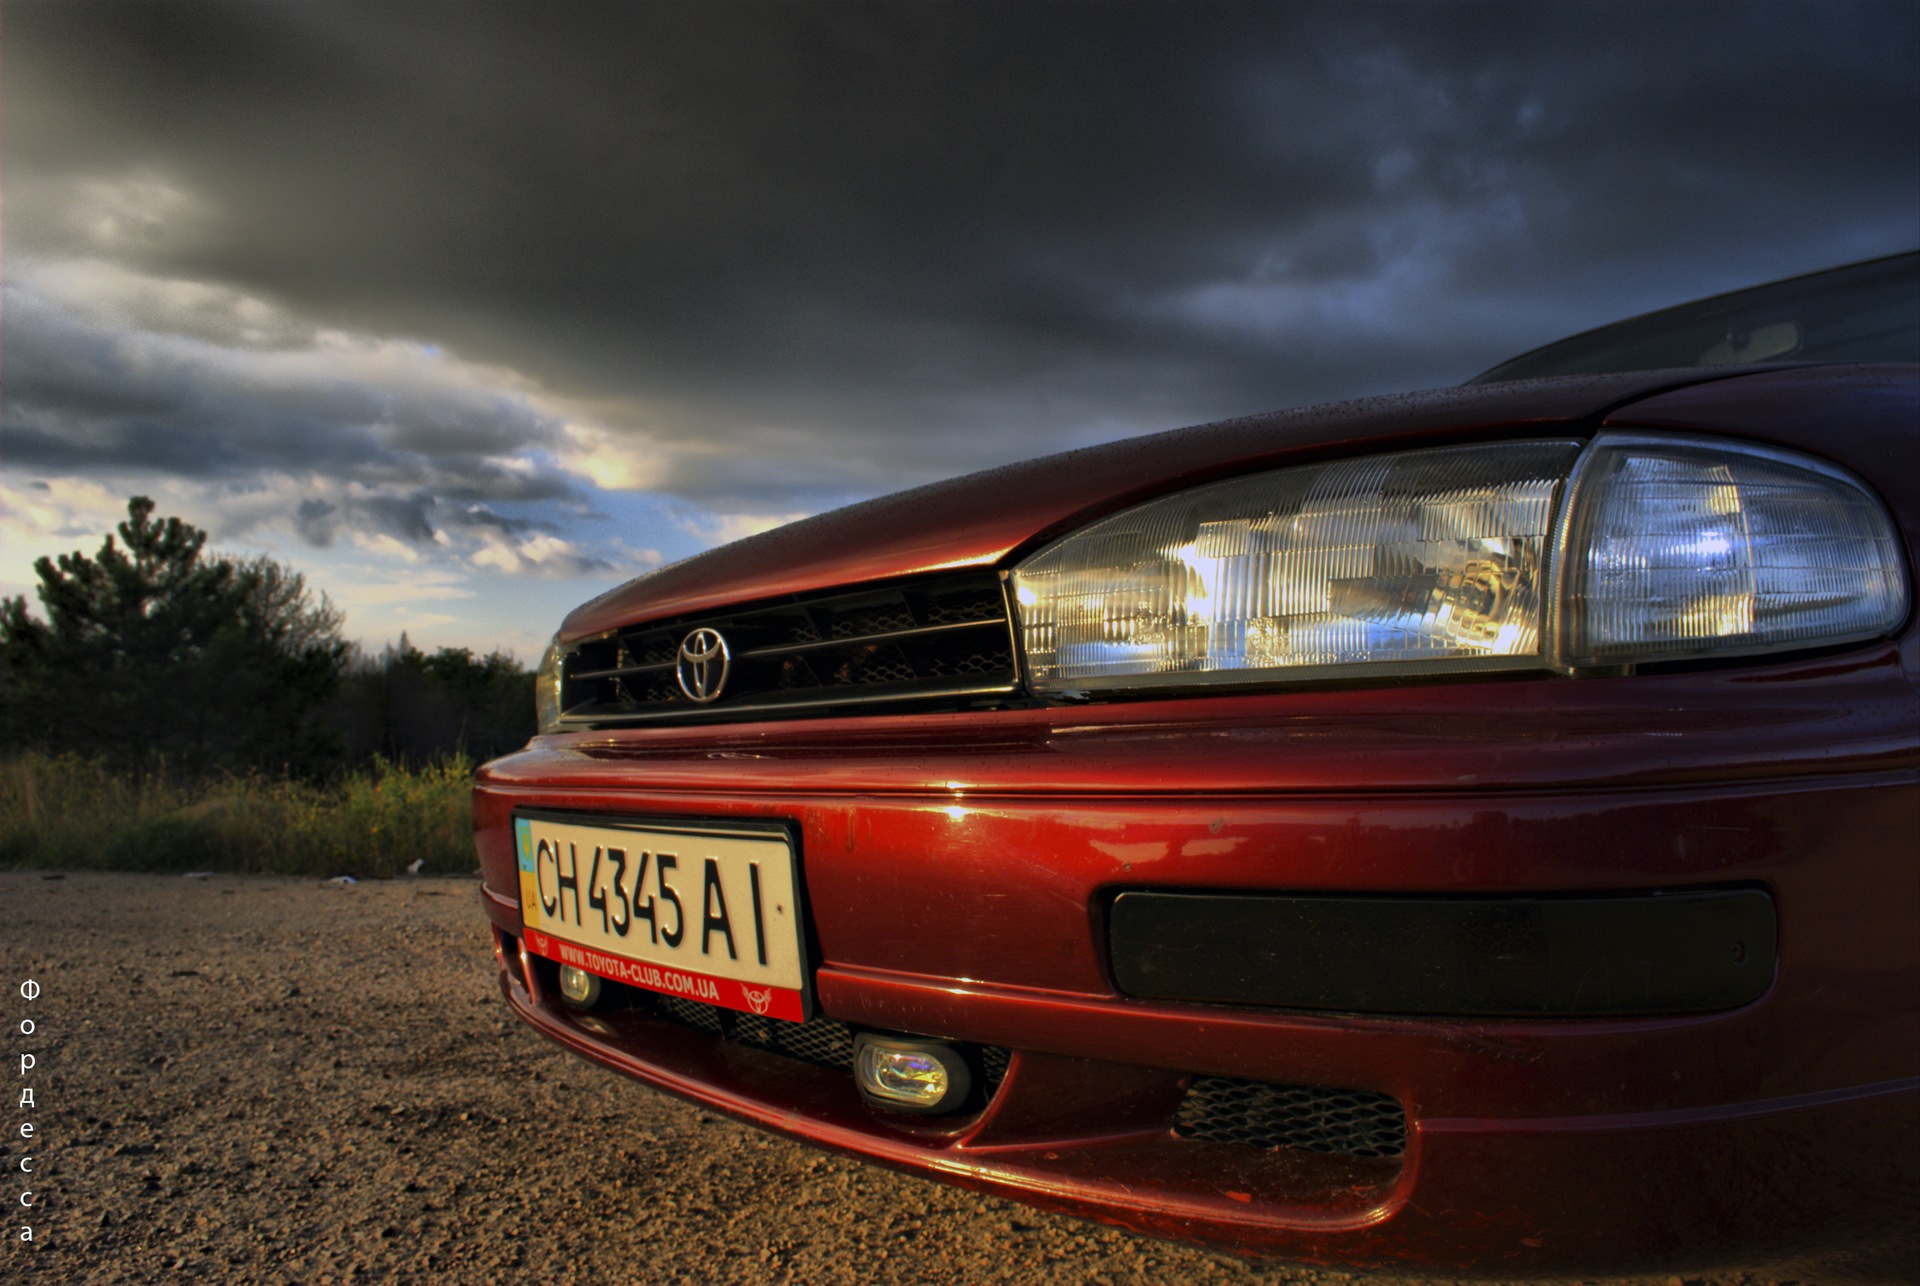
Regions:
[[1563, 438, 1907, 666]]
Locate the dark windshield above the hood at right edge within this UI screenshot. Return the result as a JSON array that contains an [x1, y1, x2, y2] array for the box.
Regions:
[[1467, 251, 1920, 384]]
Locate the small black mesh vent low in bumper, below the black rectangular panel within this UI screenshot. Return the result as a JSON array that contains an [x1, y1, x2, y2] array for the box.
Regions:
[[1173, 1077, 1407, 1157]]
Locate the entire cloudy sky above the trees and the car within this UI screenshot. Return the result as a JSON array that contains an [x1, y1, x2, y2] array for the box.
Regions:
[[0, 0, 1920, 660]]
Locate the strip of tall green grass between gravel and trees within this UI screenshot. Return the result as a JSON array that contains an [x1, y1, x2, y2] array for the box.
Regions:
[[0, 754, 474, 879]]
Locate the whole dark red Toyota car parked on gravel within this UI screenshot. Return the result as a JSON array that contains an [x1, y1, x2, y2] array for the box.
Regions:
[[474, 253, 1920, 1274]]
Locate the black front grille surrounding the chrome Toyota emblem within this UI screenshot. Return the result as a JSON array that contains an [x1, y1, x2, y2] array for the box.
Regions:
[[561, 572, 1016, 724]]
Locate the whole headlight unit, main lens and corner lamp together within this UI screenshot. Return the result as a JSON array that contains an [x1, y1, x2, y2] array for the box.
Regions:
[[1014, 436, 1907, 693]]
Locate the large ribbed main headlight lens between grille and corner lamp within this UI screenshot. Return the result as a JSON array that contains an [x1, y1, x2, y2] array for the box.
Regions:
[[1014, 441, 1580, 691]]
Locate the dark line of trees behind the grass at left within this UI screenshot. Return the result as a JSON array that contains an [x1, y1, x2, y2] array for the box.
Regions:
[[0, 495, 534, 779]]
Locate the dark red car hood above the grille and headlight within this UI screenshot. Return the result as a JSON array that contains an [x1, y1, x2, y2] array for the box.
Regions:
[[561, 367, 1755, 641]]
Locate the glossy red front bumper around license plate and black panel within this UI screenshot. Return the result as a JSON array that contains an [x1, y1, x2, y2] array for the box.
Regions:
[[474, 647, 1920, 1274]]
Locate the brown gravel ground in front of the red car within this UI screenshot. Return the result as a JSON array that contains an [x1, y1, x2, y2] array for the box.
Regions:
[[0, 871, 1889, 1286]]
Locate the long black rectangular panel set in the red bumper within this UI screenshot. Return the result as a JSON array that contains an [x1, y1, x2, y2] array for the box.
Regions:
[[1108, 889, 1776, 1017]]
